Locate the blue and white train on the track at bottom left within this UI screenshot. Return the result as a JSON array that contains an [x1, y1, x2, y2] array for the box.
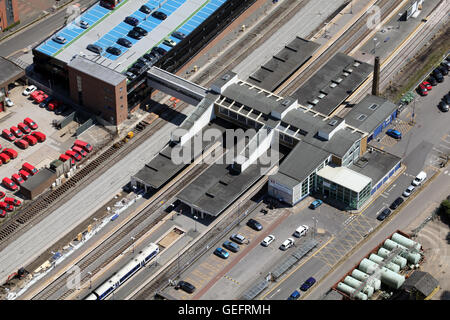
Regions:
[[84, 243, 159, 300]]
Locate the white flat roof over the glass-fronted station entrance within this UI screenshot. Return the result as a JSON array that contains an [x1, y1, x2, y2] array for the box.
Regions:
[[317, 165, 372, 192]]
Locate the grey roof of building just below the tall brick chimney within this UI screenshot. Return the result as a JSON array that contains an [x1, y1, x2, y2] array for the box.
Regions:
[[344, 95, 397, 134]]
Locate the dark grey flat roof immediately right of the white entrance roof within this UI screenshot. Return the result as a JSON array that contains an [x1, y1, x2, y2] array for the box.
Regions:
[[349, 147, 402, 186]]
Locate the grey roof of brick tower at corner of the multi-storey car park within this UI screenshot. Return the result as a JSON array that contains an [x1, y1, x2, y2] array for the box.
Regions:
[[68, 55, 127, 86]]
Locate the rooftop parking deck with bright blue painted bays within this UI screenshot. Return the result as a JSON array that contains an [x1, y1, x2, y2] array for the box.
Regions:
[[36, 0, 227, 72]]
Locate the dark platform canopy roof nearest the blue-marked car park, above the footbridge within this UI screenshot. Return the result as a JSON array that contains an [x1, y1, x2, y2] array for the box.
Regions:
[[247, 37, 320, 91]]
